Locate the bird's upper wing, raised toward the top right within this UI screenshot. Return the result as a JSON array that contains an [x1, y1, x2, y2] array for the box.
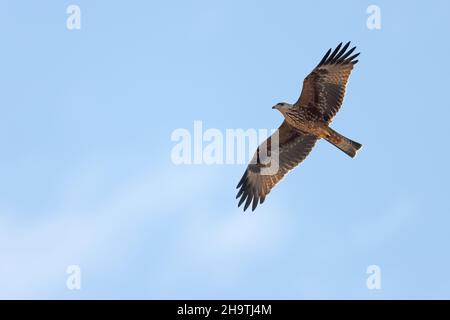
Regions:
[[295, 42, 359, 122]]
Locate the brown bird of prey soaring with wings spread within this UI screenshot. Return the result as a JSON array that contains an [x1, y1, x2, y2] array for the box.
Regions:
[[236, 42, 362, 211]]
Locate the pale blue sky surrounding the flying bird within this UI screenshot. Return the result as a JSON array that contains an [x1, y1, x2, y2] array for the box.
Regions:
[[0, 0, 450, 299]]
